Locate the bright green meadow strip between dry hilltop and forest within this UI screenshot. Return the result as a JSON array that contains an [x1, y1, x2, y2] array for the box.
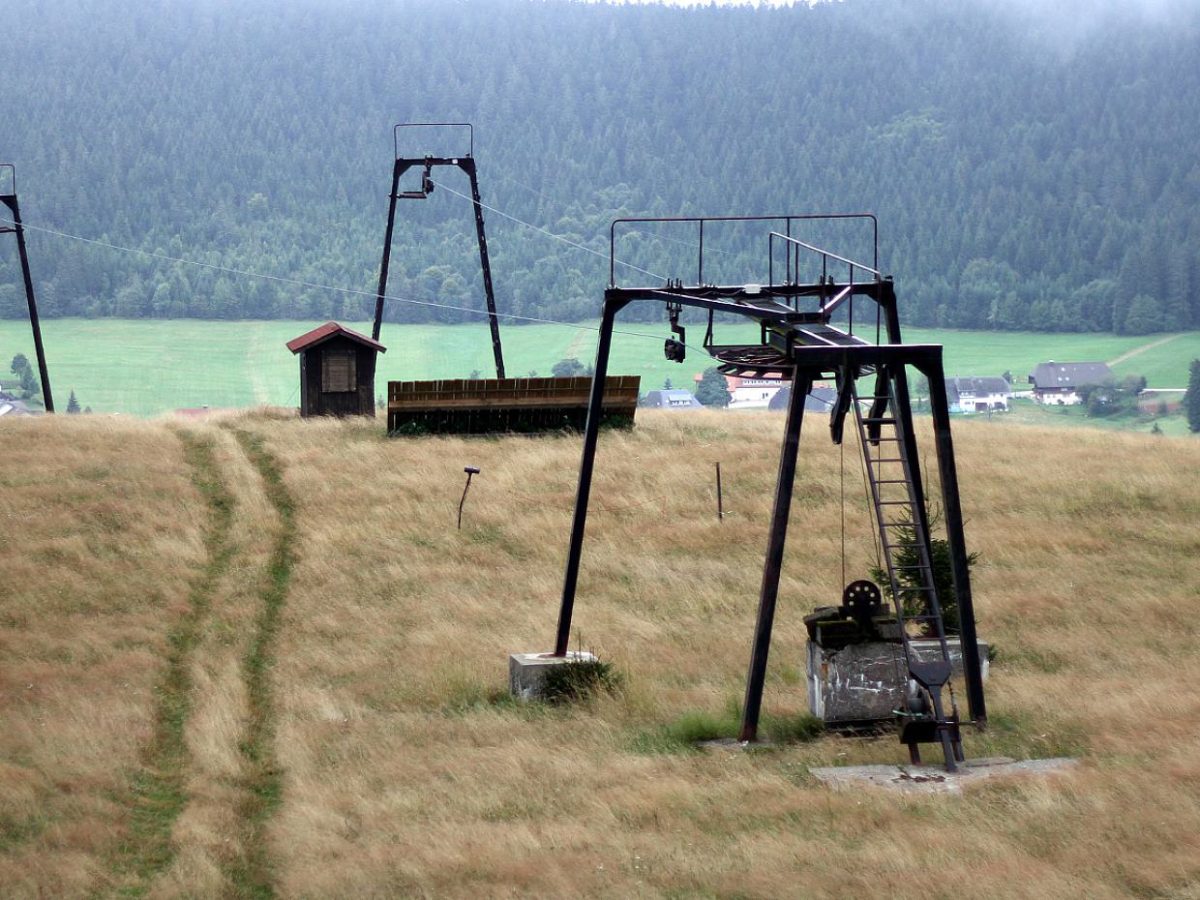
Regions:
[[0, 319, 1200, 415]]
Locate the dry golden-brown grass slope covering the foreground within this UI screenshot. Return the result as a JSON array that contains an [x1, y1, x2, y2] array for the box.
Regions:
[[0, 412, 1200, 898]]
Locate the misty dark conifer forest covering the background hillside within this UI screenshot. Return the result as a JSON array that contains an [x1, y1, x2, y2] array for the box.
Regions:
[[0, 0, 1200, 332]]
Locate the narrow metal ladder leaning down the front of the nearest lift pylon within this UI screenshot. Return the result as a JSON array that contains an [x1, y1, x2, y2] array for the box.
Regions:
[[848, 366, 962, 772]]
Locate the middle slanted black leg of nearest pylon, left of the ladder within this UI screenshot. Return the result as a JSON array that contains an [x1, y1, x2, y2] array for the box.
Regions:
[[738, 372, 812, 740]]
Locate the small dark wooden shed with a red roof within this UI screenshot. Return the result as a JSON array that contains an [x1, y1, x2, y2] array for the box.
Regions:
[[288, 322, 386, 416]]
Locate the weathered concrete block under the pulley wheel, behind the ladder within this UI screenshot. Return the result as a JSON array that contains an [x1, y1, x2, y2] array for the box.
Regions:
[[808, 638, 988, 724]]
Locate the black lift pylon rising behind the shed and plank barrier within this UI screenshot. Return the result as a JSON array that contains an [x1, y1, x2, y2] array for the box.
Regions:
[[371, 122, 504, 378]]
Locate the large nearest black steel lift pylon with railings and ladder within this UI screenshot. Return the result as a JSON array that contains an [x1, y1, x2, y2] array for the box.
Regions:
[[554, 214, 988, 770]]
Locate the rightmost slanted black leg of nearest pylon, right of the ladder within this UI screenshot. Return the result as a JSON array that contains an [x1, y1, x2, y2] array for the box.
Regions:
[[920, 364, 988, 727]]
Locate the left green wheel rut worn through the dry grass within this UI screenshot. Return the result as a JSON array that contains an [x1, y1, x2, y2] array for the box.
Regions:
[[116, 431, 236, 896]]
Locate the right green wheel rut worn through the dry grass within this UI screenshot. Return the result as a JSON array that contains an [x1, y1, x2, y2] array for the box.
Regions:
[[228, 427, 296, 898]]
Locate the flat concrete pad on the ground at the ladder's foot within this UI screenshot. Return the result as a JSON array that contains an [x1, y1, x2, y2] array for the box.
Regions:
[[810, 756, 1079, 793]]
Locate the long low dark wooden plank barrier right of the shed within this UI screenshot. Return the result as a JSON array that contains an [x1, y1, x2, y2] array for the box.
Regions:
[[388, 376, 642, 434]]
